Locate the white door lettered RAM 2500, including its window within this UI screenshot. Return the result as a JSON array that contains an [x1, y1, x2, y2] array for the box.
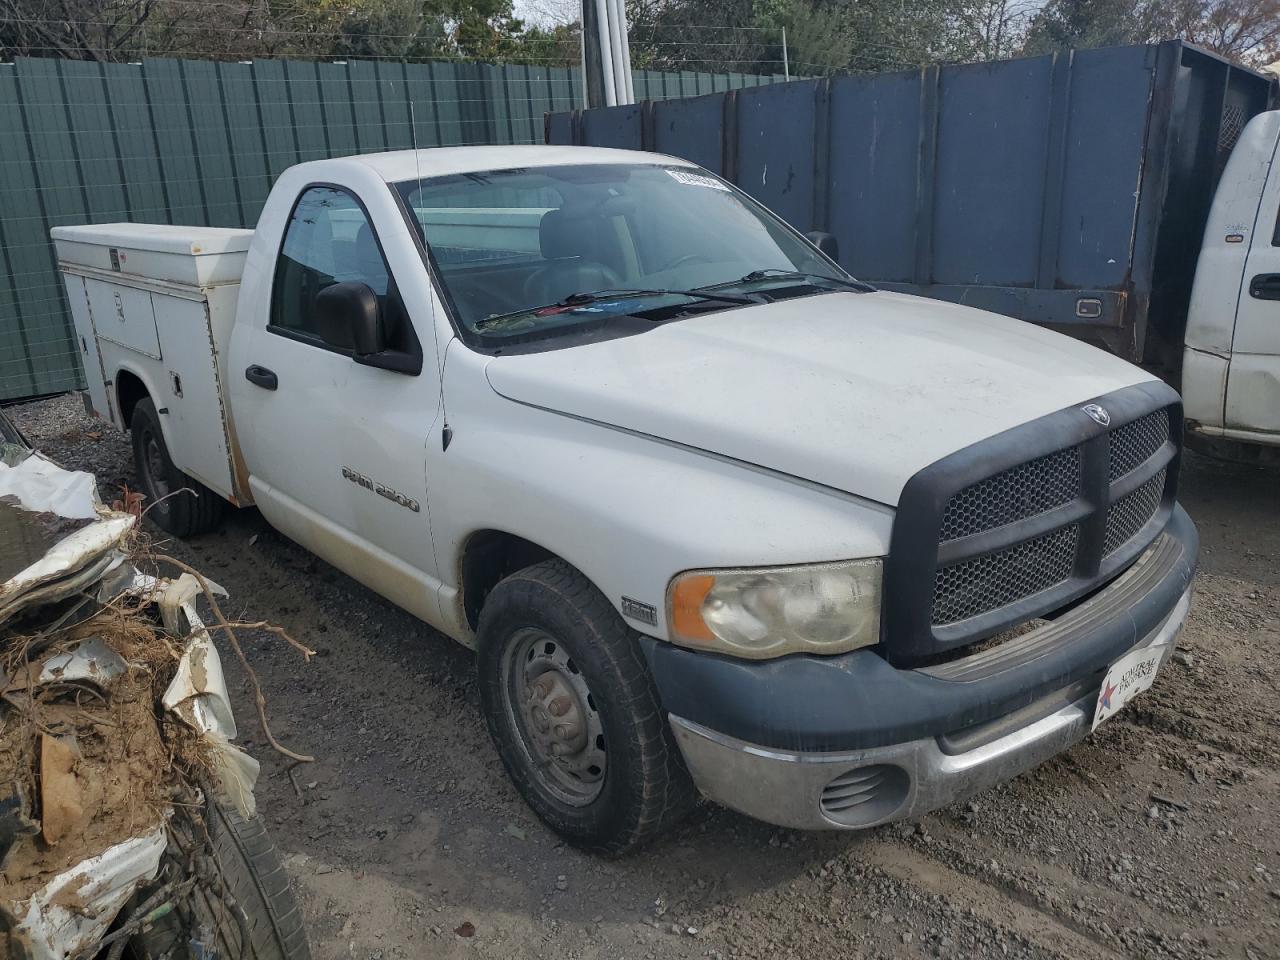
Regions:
[[232, 186, 439, 621]]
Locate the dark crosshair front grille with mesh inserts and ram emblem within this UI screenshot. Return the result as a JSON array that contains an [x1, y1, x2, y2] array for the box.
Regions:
[[884, 384, 1181, 662]]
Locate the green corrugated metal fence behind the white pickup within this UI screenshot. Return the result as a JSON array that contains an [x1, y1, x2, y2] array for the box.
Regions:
[[0, 59, 782, 401]]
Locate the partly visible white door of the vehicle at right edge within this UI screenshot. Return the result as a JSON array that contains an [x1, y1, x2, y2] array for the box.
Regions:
[[1224, 135, 1280, 439]]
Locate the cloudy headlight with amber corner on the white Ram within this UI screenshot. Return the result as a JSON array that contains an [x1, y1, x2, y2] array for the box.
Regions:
[[667, 559, 881, 659]]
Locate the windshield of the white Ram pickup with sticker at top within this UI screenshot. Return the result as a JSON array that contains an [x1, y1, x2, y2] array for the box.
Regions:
[[397, 164, 859, 342]]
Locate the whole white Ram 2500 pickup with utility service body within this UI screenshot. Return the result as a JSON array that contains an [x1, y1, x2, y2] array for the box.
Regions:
[[52, 147, 1197, 852]]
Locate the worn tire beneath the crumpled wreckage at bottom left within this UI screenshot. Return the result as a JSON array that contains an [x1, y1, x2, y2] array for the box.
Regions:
[[129, 804, 311, 960]]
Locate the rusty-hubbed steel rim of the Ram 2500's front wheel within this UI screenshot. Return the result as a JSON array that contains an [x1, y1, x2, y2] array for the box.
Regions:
[[502, 627, 608, 806]]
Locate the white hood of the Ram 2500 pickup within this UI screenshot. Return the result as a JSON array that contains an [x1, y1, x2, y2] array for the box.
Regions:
[[486, 292, 1152, 506]]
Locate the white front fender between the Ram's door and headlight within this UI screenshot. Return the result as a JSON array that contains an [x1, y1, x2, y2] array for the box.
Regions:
[[428, 351, 893, 637]]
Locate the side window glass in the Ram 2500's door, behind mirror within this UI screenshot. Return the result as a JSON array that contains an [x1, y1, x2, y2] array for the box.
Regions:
[[270, 187, 421, 353]]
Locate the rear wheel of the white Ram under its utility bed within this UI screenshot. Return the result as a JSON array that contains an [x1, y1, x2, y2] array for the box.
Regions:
[[129, 398, 227, 536]]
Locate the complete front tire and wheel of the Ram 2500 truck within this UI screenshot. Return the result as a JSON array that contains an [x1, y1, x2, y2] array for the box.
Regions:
[[476, 559, 696, 856]]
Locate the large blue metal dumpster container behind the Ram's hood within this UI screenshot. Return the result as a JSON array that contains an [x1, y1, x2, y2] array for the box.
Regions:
[[545, 41, 1276, 381]]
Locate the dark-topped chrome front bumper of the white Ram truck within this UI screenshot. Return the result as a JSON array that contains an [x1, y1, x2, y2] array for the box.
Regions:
[[649, 508, 1197, 829]]
